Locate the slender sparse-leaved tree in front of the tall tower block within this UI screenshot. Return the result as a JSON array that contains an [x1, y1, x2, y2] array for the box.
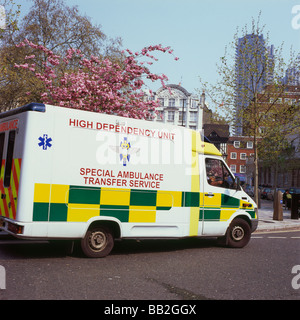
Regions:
[[200, 16, 298, 202]]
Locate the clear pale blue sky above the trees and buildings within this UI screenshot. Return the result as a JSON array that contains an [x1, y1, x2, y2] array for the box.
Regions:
[[0, 0, 300, 105]]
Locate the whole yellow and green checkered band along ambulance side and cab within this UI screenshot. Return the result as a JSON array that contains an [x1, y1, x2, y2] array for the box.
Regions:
[[33, 183, 255, 223]]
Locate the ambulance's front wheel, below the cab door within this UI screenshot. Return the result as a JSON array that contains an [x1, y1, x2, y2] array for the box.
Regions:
[[227, 218, 251, 248]]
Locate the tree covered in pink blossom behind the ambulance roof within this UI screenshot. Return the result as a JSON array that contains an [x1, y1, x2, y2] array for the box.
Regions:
[[15, 39, 178, 119]]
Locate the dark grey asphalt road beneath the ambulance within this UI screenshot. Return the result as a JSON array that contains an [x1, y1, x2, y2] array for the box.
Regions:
[[0, 231, 300, 300]]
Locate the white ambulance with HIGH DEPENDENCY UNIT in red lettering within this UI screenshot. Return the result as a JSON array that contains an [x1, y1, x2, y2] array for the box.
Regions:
[[0, 103, 258, 258]]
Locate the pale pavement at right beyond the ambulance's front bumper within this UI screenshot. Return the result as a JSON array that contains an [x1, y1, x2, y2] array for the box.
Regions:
[[255, 200, 300, 232]]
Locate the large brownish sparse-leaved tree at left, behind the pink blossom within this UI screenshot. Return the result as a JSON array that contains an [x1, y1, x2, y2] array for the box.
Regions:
[[0, 0, 122, 110]]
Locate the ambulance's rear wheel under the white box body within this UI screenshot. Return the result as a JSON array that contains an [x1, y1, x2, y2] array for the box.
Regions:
[[81, 226, 114, 258]]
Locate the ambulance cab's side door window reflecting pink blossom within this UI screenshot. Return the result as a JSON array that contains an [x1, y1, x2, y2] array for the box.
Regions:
[[205, 158, 235, 189]]
